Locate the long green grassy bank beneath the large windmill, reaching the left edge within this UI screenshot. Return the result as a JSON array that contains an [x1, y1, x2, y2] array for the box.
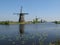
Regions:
[[0, 21, 41, 25]]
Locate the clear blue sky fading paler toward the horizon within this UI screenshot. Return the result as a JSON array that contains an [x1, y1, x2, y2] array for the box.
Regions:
[[0, 0, 60, 21]]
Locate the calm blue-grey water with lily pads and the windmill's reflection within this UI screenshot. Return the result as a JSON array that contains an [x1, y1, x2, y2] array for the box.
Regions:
[[0, 23, 60, 45]]
